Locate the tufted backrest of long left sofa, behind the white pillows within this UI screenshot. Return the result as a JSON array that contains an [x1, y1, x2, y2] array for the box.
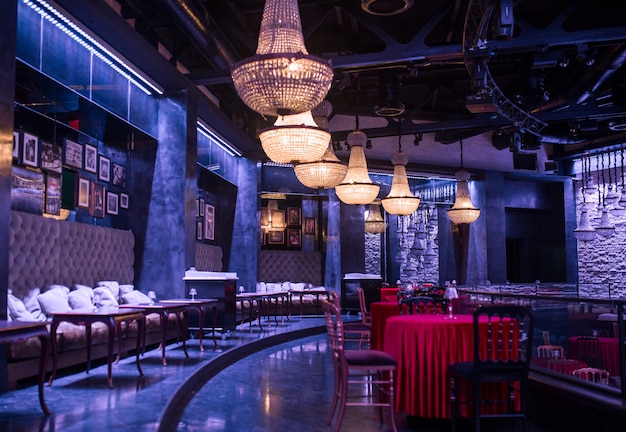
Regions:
[[9, 211, 135, 298]]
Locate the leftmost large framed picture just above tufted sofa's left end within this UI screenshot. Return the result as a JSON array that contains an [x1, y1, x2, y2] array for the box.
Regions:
[[11, 166, 44, 215]]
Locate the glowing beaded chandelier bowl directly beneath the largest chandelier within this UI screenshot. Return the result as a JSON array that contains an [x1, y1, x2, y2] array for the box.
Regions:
[[259, 111, 330, 163]]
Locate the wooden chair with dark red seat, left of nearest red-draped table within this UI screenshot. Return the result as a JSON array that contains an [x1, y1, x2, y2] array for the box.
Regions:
[[322, 300, 397, 432]]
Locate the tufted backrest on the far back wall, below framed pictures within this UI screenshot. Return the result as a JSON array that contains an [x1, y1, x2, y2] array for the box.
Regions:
[[259, 250, 323, 286]]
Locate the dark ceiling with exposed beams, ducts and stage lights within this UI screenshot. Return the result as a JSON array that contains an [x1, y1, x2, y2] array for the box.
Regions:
[[64, 0, 626, 174]]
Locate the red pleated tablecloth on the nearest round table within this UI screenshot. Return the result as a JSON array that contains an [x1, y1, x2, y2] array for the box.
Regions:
[[384, 315, 516, 418]]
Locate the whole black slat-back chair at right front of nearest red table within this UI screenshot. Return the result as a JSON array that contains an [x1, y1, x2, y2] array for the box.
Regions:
[[449, 305, 534, 432]]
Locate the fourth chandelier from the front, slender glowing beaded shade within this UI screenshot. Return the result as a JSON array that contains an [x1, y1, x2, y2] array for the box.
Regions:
[[335, 129, 380, 204]]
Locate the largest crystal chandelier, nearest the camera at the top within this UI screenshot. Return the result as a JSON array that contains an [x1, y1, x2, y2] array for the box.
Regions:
[[231, 0, 333, 116]]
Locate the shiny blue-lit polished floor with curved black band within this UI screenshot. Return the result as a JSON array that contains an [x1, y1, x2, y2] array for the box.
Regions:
[[0, 318, 548, 432]]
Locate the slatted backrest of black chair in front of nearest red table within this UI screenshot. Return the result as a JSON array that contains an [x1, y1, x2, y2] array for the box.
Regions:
[[474, 305, 534, 376]]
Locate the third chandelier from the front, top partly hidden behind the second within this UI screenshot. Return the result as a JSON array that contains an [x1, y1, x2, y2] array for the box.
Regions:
[[293, 100, 348, 189]]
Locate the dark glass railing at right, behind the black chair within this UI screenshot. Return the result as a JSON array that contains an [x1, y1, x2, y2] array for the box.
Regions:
[[458, 284, 626, 399]]
